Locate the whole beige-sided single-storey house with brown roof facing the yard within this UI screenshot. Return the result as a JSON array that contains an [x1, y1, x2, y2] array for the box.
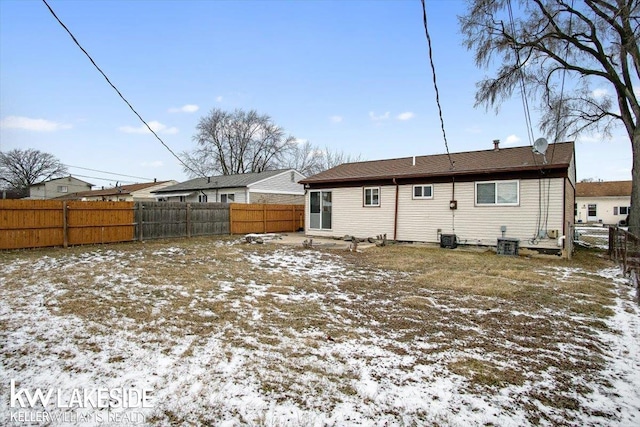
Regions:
[[301, 141, 575, 254]]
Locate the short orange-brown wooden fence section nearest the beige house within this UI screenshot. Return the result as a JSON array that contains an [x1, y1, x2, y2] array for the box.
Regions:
[[229, 203, 304, 234]]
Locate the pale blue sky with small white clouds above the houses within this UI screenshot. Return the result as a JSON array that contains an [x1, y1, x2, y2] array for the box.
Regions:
[[0, 0, 631, 186]]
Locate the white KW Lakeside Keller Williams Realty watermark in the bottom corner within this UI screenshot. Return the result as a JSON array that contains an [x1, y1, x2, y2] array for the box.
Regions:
[[9, 379, 153, 424]]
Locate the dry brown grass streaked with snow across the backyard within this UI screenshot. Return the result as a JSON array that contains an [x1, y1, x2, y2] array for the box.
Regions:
[[0, 238, 613, 422]]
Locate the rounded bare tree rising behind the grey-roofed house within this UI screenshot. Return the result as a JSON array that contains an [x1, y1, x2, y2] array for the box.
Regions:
[[182, 109, 295, 176]]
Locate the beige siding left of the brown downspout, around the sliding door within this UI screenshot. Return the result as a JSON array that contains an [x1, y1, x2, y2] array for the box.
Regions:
[[305, 186, 395, 239]]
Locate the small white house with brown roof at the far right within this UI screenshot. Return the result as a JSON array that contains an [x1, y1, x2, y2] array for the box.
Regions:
[[575, 181, 631, 225]]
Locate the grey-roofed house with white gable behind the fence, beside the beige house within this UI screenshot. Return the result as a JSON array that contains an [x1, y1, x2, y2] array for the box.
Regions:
[[155, 169, 304, 204]]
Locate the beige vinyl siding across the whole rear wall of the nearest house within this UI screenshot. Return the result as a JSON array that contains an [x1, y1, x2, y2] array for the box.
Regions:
[[305, 178, 564, 249]]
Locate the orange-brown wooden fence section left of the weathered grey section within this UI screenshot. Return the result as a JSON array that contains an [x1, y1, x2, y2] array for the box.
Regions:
[[0, 200, 135, 249]]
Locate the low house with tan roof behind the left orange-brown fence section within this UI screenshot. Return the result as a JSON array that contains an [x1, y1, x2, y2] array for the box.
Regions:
[[58, 180, 178, 202]]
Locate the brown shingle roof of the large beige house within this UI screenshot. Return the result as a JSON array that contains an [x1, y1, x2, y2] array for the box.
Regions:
[[300, 142, 573, 184]]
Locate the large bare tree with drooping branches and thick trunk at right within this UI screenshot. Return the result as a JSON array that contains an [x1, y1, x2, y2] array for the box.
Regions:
[[459, 0, 640, 233]]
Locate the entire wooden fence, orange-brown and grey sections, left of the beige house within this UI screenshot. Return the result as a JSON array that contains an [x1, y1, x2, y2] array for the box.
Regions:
[[0, 200, 304, 249]]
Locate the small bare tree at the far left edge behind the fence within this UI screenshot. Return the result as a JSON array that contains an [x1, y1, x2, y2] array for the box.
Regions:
[[0, 148, 67, 193]]
